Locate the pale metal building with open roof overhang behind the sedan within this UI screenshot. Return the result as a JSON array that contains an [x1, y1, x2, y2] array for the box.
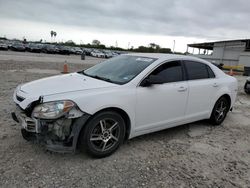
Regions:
[[187, 39, 250, 67]]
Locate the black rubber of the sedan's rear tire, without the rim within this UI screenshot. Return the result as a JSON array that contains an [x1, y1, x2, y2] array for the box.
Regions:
[[209, 97, 230, 125]]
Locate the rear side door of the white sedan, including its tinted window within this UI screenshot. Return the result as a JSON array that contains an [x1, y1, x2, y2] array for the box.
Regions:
[[184, 61, 219, 121]]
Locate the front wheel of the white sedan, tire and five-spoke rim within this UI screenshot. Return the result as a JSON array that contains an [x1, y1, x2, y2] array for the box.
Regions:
[[80, 111, 125, 158]]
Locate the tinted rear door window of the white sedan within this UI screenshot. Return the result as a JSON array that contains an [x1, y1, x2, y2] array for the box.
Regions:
[[185, 61, 215, 80]]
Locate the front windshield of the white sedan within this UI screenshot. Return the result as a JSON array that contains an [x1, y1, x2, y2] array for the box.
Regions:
[[80, 55, 156, 84]]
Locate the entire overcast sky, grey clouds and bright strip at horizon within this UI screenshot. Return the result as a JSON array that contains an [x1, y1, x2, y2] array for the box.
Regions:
[[0, 0, 250, 52]]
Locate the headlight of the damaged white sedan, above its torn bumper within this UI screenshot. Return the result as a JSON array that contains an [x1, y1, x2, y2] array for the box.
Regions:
[[32, 101, 75, 119]]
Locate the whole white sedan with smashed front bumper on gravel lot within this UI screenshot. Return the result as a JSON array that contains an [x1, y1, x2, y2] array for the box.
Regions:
[[12, 54, 238, 157]]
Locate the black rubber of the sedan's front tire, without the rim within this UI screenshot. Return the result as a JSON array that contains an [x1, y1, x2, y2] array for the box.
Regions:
[[80, 111, 126, 158]]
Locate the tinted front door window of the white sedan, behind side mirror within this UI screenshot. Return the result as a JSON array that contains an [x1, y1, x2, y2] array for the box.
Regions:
[[151, 61, 183, 83]]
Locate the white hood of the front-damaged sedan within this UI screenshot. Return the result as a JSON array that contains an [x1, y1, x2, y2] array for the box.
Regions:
[[20, 73, 116, 97]]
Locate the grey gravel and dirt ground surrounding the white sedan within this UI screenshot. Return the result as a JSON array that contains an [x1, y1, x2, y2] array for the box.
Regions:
[[0, 51, 250, 188]]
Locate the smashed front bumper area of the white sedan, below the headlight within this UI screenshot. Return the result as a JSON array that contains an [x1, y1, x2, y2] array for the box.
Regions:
[[11, 106, 90, 153]]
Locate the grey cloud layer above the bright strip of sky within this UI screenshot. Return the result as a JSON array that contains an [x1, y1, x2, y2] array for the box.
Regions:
[[0, 0, 250, 39]]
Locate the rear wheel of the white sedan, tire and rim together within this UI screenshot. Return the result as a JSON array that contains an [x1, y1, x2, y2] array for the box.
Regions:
[[210, 97, 230, 125]]
